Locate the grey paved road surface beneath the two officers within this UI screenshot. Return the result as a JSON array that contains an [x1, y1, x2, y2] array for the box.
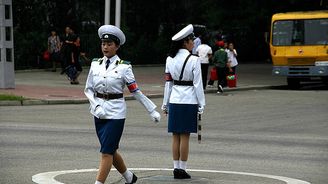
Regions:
[[0, 88, 328, 184]]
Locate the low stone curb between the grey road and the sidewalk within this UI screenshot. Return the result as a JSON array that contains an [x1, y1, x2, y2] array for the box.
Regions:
[[0, 86, 277, 106]]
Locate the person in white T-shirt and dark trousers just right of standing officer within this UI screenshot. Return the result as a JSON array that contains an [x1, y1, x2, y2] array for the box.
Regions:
[[196, 35, 212, 89]]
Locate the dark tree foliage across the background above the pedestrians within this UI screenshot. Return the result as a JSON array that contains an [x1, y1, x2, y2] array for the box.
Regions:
[[13, 0, 328, 68]]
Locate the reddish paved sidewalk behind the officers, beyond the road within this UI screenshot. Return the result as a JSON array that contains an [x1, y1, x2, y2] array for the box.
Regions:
[[0, 64, 286, 106]]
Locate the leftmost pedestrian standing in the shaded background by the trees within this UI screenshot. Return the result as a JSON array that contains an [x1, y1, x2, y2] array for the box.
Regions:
[[48, 29, 60, 72]]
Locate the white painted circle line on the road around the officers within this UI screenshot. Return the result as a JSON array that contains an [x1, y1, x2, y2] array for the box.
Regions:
[[32, 168, 311, 184]]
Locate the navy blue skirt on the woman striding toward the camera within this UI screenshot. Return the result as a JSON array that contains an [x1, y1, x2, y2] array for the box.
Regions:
[[95, 117, 125, 155]]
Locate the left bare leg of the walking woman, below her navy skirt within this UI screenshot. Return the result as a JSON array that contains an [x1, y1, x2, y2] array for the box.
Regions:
[[97, 154, 113, 183]]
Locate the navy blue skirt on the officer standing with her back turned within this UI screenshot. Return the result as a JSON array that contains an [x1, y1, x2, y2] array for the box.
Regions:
[[168, 103, 198, 133]]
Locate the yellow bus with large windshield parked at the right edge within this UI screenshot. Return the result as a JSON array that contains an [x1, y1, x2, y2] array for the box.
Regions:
[[270, 11, 328, 89]]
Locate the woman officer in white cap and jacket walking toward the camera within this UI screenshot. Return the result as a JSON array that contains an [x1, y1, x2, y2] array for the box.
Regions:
[[84, 25, 160, 184]]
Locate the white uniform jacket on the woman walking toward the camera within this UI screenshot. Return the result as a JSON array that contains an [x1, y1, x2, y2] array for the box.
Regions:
[[84, 55, 156, 119]]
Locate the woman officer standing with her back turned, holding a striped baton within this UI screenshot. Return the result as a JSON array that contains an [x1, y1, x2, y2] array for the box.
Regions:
[[162, 24, 205, 179]]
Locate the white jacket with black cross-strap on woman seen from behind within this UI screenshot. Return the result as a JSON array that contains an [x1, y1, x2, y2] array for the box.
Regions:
[[163, 49, 205, 107]]
